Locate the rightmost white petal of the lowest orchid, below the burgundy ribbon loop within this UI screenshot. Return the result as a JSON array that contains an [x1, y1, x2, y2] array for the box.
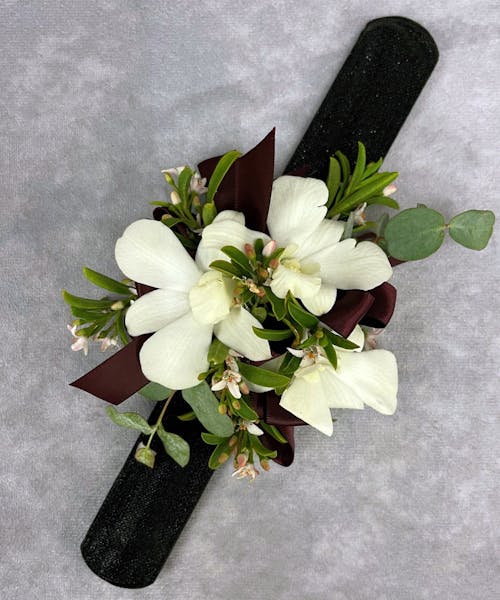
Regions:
[[336, 350, 398, 415]]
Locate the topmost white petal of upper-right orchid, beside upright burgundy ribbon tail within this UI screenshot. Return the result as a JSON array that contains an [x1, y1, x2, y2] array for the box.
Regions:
[[267, 175, 328, 247]]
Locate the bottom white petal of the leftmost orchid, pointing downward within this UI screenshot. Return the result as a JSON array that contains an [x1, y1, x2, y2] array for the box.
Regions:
[[139, 311, 212, 390]]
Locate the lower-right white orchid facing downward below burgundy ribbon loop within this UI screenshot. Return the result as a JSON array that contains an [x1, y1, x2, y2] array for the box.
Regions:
[[280, 325, 398, 435]]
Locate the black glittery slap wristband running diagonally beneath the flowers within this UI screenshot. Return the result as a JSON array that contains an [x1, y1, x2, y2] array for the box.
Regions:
[[81, 17, 438, 588]]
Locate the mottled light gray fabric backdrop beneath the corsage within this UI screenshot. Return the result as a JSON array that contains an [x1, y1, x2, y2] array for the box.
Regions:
[[0, 0, 500, 600]]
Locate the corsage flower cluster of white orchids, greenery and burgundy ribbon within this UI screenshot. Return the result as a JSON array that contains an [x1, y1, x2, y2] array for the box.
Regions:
[[63, 134, 495, 480]]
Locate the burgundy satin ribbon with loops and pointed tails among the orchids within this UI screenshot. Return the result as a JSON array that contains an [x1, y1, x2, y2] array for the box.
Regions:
[[71, 134, 400, 466]]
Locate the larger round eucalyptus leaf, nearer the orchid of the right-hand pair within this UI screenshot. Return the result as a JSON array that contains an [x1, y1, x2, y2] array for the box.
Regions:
[[384, 207, 446, 260]]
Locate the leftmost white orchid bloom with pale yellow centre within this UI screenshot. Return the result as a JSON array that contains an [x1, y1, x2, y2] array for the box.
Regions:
[[115, 219, 271, 390]]
